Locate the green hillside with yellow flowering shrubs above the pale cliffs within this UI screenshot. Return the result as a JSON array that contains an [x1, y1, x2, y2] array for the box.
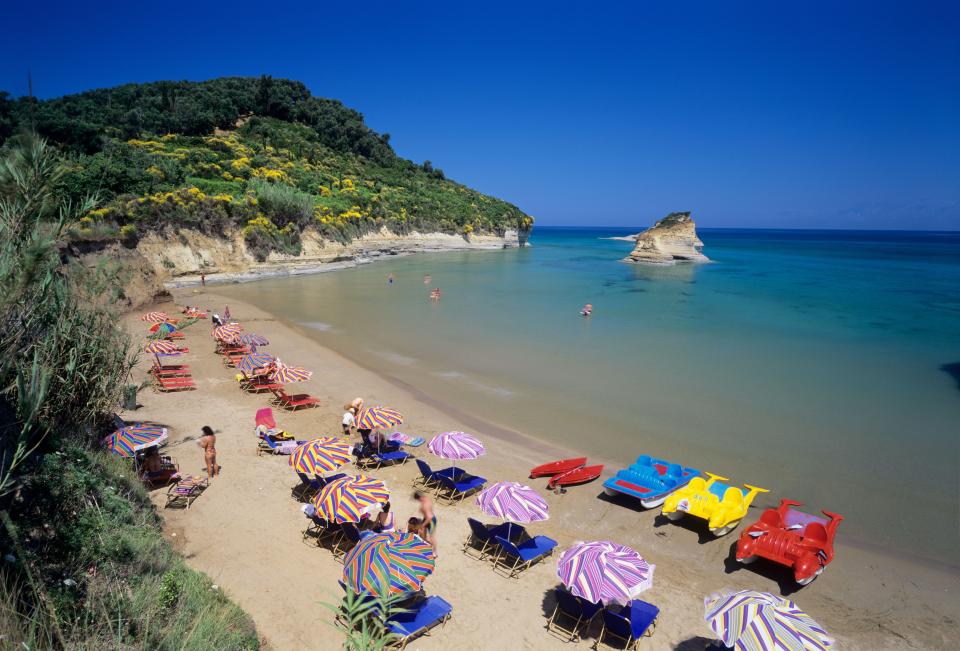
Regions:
[[0, 77, 533, 257]]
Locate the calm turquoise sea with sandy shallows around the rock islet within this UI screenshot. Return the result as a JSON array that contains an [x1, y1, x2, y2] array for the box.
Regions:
[[218, 228, 960, 565]]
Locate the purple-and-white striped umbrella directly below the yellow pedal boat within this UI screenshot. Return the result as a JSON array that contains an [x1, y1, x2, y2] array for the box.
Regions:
[[557, 540, 654, 605]]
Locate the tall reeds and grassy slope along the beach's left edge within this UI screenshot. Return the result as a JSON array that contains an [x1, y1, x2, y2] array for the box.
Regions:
[[0, 139, 258, 650]]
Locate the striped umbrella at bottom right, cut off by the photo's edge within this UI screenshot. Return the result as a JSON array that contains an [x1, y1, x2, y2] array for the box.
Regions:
[[704, 590, 833, 651]]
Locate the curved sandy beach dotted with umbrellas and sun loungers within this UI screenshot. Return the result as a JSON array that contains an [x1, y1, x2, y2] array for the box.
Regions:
[[122, 288, 960, 649]]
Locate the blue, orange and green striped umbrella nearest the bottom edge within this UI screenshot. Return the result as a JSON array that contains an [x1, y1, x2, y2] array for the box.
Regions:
[[343, 532, 436, 594]]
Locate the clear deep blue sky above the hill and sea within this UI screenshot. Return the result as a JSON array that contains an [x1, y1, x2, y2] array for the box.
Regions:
[[0, 0, 960, 229]]
